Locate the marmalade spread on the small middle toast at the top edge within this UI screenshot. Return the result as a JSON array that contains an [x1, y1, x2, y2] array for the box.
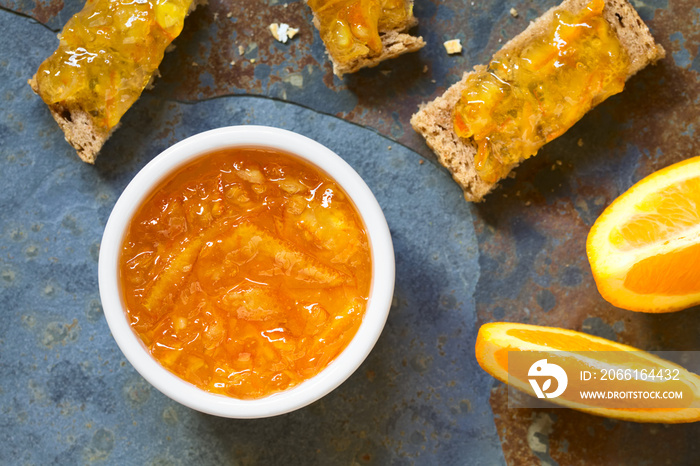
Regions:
[[308, 0, 412, 63]]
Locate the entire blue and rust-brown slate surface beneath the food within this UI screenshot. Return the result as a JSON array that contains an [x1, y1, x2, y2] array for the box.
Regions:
[[0, 0, 700, 465]]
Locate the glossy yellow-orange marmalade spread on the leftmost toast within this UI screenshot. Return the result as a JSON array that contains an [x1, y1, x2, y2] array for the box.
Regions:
[[36, 0, 192, 130]]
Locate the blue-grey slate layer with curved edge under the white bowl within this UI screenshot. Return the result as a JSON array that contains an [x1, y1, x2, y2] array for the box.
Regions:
[[0, 12, 503, 464]]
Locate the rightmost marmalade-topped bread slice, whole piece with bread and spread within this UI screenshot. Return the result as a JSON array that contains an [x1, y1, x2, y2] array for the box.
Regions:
[[411, 0, 665, 202]]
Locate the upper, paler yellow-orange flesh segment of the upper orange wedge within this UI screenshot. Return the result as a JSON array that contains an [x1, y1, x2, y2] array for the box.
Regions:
[[610, 177, 700, 251]]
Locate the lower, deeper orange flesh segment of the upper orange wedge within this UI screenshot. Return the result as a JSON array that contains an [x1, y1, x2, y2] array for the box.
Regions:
[[624, 243, 700, 296]]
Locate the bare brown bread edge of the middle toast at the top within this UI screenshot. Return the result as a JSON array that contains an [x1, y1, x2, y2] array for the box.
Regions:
[[314, 1, 425, 78]]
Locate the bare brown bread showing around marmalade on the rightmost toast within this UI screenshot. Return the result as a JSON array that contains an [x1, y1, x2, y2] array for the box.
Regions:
[[411, 0, 665, 202]]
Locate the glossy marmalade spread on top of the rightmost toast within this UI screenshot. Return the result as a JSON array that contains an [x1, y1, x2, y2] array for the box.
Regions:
[[453, 0, 629, 182]]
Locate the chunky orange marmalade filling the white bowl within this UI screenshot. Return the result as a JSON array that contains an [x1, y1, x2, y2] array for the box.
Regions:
[[119, 147, 371, 399]]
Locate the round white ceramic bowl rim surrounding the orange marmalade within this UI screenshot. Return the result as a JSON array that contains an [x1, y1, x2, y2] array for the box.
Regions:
[[99, 126, 394, 418]]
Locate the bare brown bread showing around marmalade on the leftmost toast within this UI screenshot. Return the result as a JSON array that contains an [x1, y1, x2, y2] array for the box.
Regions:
[[27, 0, 207, 164]]
